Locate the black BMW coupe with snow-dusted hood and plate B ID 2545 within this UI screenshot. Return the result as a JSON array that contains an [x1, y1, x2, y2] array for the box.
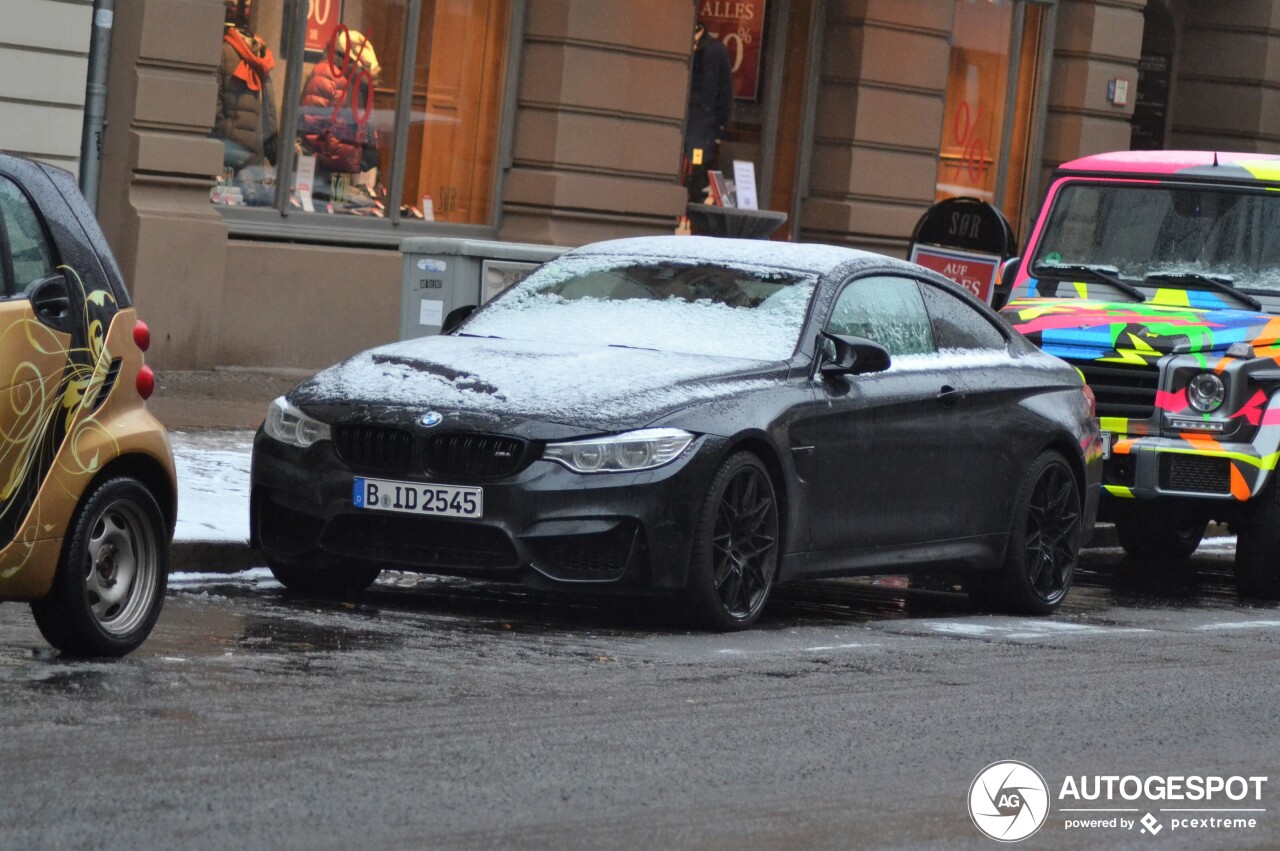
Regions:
[[251, 237, 1102, 630]]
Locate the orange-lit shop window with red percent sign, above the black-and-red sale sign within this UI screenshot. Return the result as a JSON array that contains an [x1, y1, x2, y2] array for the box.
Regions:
[[936, 0, 1051, 236]]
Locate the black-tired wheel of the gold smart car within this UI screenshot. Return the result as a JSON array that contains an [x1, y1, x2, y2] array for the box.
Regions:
[[31, 476, 169, 656]]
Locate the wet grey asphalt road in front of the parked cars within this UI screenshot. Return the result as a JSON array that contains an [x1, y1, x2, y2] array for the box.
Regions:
[[0, 541, 1280, 848]]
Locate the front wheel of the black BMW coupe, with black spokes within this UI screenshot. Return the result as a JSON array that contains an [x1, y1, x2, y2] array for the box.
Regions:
[[689, 452, 780, 631]]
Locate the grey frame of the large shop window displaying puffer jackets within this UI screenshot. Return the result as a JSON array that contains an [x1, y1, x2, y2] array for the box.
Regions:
[[217, 0, 527, 247]]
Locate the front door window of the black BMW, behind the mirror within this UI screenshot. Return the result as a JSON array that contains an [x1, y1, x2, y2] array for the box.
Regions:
[[827, 275, 936, 354]]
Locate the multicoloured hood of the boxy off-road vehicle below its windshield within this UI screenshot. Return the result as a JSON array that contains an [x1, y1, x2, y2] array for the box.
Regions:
[[1001, 298, 1280, 363]]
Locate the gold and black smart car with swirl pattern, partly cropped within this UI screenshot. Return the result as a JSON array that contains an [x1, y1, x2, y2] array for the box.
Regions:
[[0, 156, 177, 656]]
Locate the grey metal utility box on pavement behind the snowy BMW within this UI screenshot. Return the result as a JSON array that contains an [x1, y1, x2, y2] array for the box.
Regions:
[[399, 237, 568, 340]]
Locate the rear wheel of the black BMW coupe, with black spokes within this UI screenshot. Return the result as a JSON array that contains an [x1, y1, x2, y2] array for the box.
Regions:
[[969, 450, 1082, 614]]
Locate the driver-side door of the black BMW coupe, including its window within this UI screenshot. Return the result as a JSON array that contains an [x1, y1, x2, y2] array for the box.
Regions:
[[792, 274, 951, 552]]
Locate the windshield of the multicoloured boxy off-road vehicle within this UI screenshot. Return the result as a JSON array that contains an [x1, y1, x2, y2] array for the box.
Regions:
[[1030, 183, 1280, 293]]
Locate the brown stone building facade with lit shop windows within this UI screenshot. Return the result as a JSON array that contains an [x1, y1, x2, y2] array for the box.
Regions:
[[77, 0, 1280, 369]]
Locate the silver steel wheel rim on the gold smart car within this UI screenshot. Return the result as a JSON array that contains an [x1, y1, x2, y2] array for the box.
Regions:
[[84, 499, 160, 636]]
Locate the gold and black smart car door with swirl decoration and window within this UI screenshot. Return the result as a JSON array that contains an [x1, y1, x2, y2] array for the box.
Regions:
[[0, 175, 74, 544]]
